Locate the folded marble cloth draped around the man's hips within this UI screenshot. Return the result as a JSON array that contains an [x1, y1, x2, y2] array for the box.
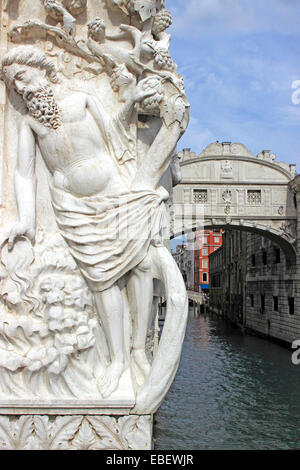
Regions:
[[51, 186, 165, 291]]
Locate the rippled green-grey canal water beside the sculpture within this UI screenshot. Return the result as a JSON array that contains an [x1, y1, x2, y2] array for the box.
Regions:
[[154, 314, 300, 450]]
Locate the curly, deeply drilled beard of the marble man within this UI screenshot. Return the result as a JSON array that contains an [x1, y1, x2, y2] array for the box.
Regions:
[[22, 84, 61, 129]]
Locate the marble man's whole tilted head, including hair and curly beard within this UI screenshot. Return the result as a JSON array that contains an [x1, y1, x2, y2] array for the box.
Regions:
[[1, 46, 60, 129]]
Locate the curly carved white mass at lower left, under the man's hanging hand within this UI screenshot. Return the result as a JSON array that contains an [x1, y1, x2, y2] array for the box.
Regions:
[[0, 230, 107, 399]]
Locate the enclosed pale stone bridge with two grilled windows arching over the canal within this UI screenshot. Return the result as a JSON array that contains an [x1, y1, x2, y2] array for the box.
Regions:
[[172, 142, 297, 266]]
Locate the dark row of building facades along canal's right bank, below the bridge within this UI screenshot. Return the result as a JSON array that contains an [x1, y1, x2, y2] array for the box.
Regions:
[[210, 231, 300, 344]]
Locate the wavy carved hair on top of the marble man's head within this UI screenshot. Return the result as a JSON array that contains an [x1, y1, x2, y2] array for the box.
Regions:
[[0, 46, 57, 86]]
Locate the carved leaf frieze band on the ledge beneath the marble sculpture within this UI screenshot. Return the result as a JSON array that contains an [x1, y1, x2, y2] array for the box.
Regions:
[[0, 416, 152, 450]]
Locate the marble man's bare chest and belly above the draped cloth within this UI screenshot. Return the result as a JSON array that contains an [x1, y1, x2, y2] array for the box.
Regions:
[[27, 93, 126, 196]]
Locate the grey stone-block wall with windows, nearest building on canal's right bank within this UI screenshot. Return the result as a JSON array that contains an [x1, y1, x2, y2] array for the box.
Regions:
[[244, 234, 300, 343]]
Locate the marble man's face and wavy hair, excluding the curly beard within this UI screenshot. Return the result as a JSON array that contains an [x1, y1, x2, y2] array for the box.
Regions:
[[1, 46, 56, 97]]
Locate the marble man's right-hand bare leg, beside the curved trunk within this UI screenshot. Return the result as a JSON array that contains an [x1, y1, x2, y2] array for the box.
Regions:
[[127, 255, 153, 382]]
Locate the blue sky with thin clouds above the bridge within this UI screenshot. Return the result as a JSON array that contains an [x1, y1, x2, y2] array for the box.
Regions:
[[166, 0, 300, 172]]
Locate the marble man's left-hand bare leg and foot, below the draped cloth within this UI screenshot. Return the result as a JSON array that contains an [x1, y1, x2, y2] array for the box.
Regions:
[[95, 284, 127, 398]]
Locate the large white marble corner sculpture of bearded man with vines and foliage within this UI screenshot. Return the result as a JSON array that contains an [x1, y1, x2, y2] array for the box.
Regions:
[[0, 0, 189, 450]]
